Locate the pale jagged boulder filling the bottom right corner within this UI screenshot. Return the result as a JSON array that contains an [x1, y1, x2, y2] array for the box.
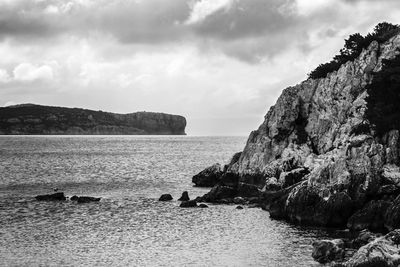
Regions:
[[345, 230, 400, 267]]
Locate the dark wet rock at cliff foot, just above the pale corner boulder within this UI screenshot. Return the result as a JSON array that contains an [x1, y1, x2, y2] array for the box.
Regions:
[[347, 200, 390, 231]]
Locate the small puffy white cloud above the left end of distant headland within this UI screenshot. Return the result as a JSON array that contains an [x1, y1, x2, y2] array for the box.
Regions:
[[13, 63, 54, 82]]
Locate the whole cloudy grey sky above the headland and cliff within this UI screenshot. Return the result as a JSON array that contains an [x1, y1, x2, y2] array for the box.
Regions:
[[0, 0, 400, 135]]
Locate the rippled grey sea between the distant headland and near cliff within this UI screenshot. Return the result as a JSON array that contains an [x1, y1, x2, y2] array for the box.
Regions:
[[0, 136, 344, 266]]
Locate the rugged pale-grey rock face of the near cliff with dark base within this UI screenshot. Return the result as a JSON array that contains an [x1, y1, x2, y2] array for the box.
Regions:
[[198, 34, 400, 230]]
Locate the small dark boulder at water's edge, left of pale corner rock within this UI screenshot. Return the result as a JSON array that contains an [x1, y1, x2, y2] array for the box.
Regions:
[[312, 239, 344, 263]]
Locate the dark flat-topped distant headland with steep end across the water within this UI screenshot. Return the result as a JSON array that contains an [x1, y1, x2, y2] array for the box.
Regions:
[[0, 104, 186, 135]]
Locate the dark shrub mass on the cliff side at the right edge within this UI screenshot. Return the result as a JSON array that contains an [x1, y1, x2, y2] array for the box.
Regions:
[[366, 55, 400, 136]]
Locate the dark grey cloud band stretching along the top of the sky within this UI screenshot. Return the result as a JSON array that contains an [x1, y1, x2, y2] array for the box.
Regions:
[[0, 0, 395, 63]]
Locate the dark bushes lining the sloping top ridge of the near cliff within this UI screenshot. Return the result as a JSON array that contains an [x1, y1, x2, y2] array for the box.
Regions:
[[308, 22, 400, 79]]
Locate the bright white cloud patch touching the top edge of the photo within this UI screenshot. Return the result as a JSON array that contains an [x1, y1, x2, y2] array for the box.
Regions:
[[186, 0, 233, 24]]
